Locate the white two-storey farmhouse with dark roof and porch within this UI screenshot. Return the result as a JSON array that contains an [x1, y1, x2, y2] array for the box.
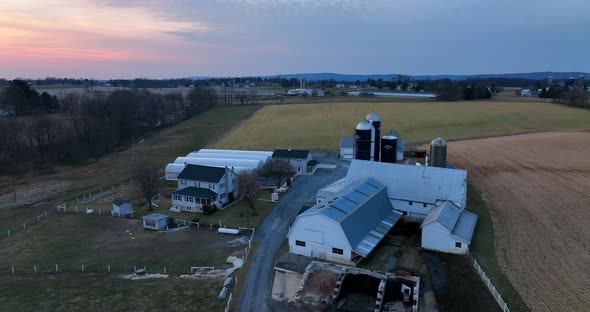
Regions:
[[170, 165, 238, 212]]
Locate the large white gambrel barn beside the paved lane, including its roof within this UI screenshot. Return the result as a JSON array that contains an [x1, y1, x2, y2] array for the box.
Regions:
[[288, 179, 401, 265]]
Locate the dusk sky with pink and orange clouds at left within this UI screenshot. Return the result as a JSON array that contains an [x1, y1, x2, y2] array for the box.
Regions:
[[0, 0, 590, 79]]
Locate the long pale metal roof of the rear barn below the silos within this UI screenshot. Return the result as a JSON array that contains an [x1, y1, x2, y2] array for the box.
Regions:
[[345, 159, 467, 208]]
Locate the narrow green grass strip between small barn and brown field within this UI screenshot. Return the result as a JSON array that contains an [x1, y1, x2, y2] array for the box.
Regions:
[[467, 184, 530, 312]]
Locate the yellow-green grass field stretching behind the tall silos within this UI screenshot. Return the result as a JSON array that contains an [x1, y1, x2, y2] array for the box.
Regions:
[[214, 98, 590, 150]]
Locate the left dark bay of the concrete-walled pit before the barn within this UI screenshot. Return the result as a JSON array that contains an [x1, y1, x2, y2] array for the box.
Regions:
[[328, 274, 381, 311]]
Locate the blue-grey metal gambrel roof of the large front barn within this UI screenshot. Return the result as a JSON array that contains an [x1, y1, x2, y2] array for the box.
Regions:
[[301, 178, 401, 257]]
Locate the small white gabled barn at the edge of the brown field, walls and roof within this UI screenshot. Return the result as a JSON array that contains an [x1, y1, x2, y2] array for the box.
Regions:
[[421, 201, 477, 254]]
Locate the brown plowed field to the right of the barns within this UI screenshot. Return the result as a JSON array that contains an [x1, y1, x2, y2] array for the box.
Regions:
[[449, 133, 590, 311]]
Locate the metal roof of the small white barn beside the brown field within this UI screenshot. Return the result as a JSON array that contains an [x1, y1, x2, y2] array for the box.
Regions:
[[421, 201, 477, 244]]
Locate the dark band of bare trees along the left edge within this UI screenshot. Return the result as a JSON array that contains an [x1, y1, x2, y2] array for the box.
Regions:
[[0, 81, 218, 172]]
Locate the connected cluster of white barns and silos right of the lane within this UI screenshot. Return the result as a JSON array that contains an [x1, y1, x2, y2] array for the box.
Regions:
[[288, 113, 477, 265]]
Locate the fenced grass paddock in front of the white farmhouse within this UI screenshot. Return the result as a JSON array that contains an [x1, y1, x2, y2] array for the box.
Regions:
[[0, 213, 247, 274]]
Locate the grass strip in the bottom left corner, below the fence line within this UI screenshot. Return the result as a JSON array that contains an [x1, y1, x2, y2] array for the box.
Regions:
[[0, 274, 226, 312]]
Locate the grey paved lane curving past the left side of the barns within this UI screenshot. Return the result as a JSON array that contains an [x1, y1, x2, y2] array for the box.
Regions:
[[238, 162, 348, 312]]
